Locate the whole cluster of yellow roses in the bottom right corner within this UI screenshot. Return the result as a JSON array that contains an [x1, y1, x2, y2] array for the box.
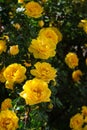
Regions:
[[70, 106, 87, 130]]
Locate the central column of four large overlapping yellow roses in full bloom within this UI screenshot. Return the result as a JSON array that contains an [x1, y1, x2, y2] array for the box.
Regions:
[[20, 24, 62, 105]]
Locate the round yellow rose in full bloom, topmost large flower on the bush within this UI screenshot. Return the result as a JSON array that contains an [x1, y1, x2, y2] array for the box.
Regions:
[[25, 1, 43, 18]]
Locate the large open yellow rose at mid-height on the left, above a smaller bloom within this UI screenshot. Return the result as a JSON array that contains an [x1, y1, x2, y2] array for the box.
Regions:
[[3, 63, 26, 86]]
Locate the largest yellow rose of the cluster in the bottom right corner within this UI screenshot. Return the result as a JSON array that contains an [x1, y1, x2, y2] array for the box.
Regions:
[[70, 113, 84, 130]]
